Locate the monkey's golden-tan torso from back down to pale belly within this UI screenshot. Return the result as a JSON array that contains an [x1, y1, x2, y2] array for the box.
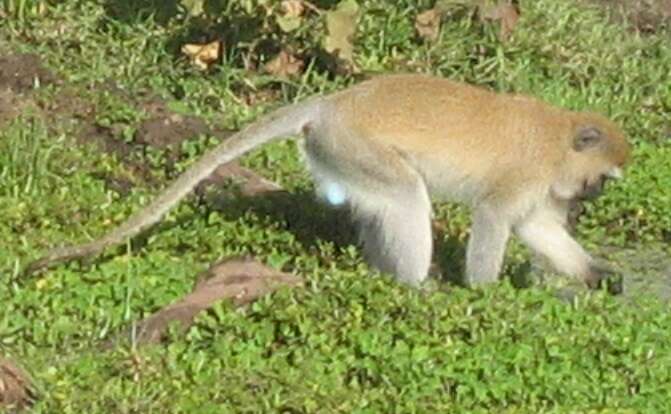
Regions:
[[333, 75, 570, 199]]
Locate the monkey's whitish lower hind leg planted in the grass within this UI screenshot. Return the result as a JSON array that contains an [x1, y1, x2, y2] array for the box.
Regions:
[[351, 178, 433, 286]]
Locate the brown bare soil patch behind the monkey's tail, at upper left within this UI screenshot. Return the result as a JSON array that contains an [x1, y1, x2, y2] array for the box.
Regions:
[[0, 54, 280, 199]]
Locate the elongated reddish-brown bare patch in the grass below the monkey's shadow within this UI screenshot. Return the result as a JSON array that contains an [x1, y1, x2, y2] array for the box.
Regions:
[[124, 259, 303, 344]]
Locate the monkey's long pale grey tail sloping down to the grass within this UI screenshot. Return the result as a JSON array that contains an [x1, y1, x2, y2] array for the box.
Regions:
[[25, 100, 319, 274]]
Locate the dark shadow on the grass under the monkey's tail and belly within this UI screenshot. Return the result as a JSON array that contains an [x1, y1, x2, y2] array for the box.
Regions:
[[201, 190, 465, 285]]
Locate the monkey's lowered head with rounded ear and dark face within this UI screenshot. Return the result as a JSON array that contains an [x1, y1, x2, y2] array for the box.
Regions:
[[552, 113, 631, 200]]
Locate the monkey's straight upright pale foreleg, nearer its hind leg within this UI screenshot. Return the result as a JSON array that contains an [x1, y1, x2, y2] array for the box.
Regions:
[[465, 205, 510, 286]]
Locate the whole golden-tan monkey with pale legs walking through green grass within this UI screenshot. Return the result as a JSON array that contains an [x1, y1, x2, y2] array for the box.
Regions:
[[29, 75, 630, 288]]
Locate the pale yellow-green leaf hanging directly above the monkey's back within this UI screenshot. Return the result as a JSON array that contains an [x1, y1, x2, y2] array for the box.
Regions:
[[324, 0, 359, 72]]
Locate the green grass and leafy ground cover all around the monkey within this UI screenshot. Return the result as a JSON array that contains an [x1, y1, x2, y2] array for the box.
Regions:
[[0, 0, 671, 413]]
